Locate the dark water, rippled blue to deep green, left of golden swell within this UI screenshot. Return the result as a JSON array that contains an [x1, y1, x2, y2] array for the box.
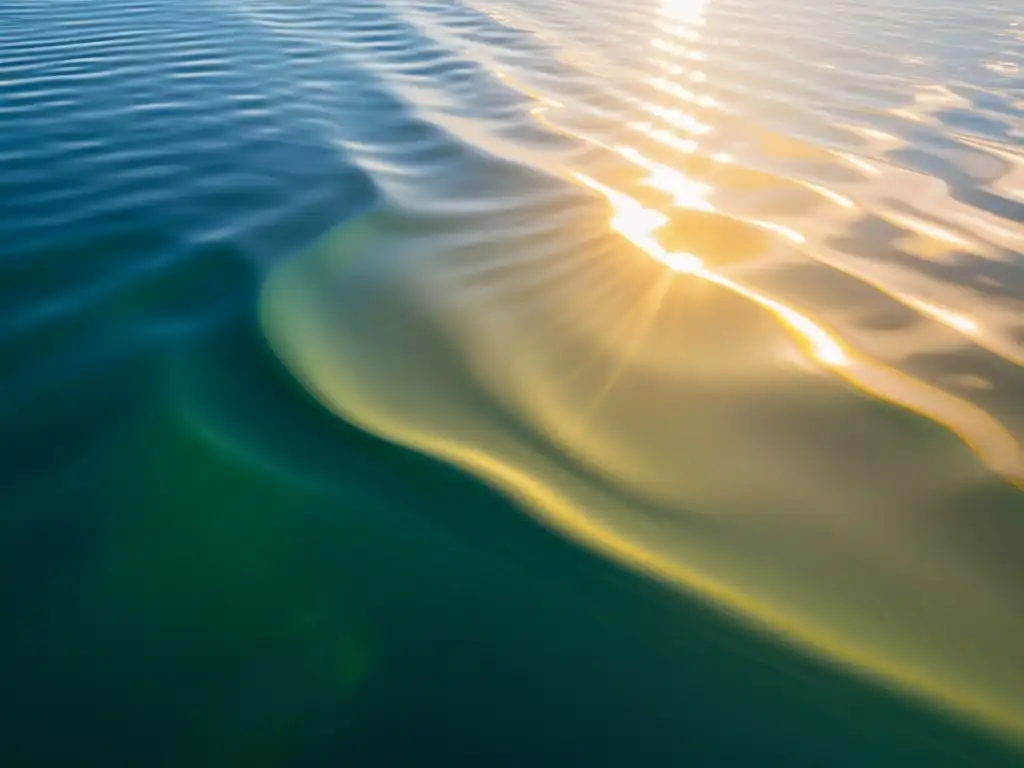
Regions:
[[0, 0, 1022, 768]]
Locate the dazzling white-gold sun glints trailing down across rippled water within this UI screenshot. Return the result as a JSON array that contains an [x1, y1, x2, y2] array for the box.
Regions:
[[512, 0, 1024, 475]]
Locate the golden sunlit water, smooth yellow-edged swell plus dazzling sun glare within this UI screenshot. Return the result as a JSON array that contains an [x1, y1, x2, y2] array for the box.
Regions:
[[267, 0, 1024, 753]]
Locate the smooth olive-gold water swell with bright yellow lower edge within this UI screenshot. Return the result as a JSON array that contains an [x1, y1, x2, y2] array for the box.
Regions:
[[263, 204, 1024, 736]]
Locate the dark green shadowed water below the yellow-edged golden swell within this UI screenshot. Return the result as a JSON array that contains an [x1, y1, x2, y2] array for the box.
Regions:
[[0, 237, 1014, 767]]
